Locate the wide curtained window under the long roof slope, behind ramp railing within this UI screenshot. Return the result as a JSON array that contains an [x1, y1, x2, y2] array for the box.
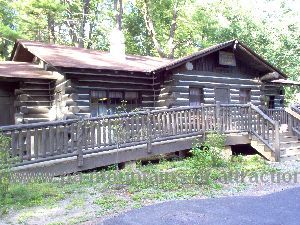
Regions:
[[91, 91, 140, 117]]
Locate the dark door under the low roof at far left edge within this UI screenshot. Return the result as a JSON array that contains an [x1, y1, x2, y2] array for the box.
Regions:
[[0, 85, 15, 126]]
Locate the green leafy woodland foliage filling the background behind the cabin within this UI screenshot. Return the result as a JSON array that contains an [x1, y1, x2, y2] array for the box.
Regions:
[[0, 0, 300, 92]]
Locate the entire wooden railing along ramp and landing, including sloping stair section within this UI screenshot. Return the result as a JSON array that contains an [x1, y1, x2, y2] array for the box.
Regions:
[[0, 104, 279, 166]]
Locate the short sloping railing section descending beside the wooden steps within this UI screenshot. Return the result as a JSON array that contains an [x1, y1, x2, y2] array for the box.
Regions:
[[249, 105, 280, 161]]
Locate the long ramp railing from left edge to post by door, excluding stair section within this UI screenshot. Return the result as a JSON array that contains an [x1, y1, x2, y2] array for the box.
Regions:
[[1, 105, 216, 165]]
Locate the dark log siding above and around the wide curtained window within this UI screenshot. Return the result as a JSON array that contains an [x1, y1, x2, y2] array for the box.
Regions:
[[65, 70, 159, 117]]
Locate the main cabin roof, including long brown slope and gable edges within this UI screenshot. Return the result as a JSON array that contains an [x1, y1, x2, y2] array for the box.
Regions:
[[14, 40, 287, 78]]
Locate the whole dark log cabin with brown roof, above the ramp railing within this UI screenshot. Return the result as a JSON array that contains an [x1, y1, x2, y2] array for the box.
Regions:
[[0, 40, 287, 125]]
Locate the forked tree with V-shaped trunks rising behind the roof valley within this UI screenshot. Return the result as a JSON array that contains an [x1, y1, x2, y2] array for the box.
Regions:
[[137, 0, 197, 59]]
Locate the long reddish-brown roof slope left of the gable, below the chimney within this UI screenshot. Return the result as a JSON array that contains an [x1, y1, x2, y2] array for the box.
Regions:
[[15, 40, 171, 72]]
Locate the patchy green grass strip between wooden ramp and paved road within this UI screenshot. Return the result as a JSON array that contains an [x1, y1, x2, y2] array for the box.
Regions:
[[0, 149, 273, 220]]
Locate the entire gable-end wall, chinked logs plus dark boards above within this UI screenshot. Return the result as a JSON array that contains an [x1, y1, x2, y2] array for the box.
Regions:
[[156, 50, 280, 107]]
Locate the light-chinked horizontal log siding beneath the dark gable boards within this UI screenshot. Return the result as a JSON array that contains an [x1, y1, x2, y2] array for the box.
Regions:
[[158, 70, 263, 107]]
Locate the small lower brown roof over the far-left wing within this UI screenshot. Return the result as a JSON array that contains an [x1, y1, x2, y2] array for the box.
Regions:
[[0, 61, 56, 79]]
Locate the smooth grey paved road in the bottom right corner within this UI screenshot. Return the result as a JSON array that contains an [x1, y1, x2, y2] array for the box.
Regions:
[[104, 188, 300, 225]]
